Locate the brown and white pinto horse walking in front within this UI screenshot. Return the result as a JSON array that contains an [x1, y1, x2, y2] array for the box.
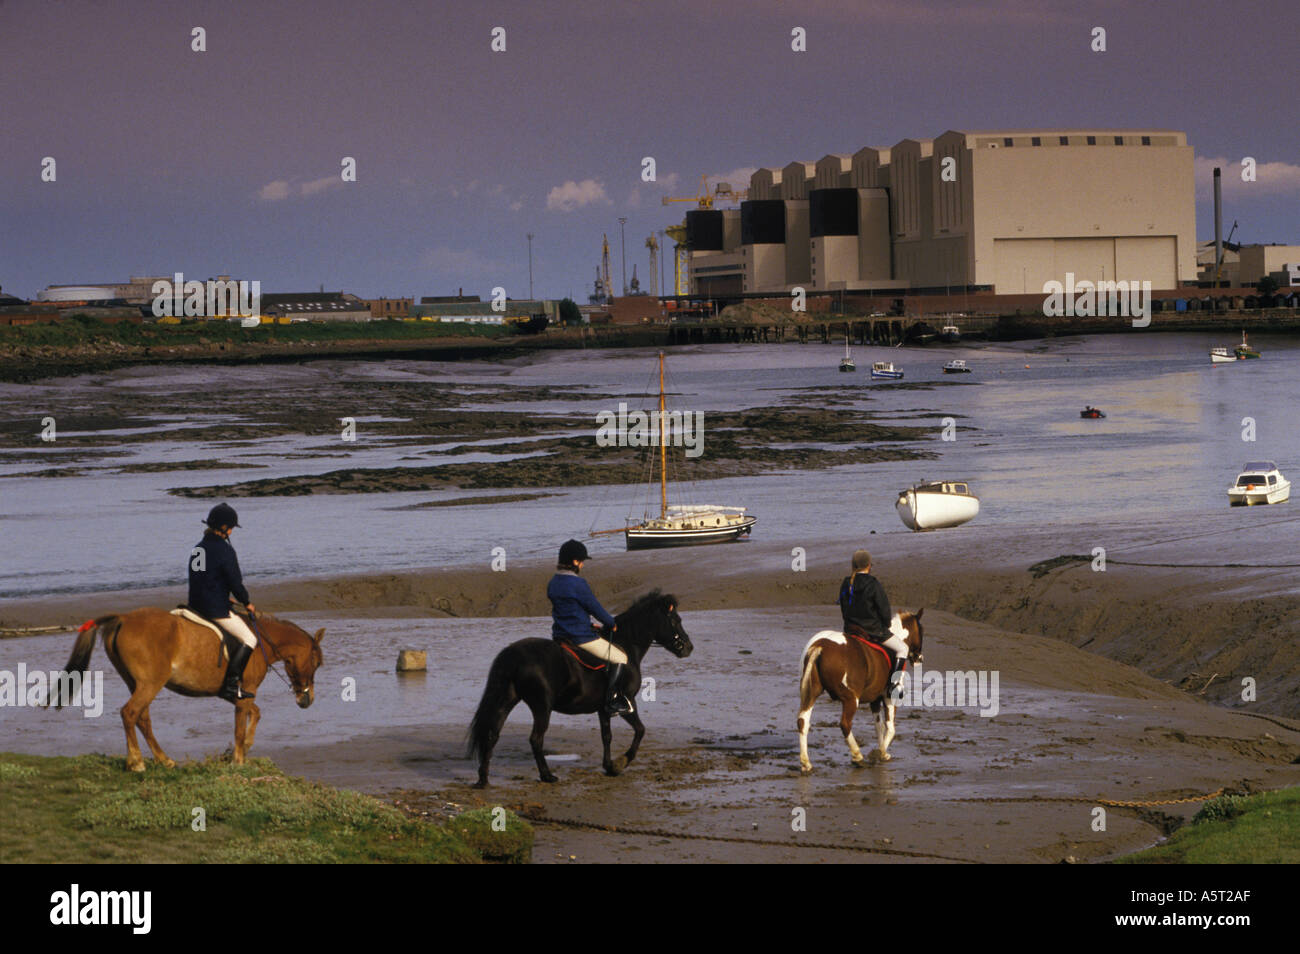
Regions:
[[798, 610, 924, 775]]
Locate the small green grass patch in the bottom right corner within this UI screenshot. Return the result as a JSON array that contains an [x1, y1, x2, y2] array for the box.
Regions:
[[1118, 788, 1300, 864]]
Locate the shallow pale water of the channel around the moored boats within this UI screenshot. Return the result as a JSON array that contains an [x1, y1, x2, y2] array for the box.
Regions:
[[0, 331, 1300, 598]]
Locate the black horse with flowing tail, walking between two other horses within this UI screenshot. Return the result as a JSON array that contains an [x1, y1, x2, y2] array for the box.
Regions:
[[467, 590, 694, 789]]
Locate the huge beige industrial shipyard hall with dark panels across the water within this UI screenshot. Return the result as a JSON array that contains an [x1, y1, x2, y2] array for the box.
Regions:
[[686, 129, 1197, 296]]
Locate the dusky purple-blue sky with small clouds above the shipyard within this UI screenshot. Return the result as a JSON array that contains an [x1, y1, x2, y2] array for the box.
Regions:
[[0, 0, 1300, 302]]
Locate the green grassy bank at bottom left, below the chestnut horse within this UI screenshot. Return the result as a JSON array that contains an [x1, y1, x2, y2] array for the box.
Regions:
[[0, 753, 533, 864]]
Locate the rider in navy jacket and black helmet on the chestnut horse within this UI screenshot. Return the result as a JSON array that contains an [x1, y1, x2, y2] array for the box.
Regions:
[[189, 503, 257, 702]]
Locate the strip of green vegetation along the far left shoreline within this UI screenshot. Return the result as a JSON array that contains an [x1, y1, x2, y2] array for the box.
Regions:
[[0, 315, 511, 347]]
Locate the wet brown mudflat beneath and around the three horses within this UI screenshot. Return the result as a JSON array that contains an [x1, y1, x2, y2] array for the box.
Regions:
[[0, 529, 1300, 862]]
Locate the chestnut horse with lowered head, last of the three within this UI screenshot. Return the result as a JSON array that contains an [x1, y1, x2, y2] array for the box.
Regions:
[[53, 608, 325, 772]]
